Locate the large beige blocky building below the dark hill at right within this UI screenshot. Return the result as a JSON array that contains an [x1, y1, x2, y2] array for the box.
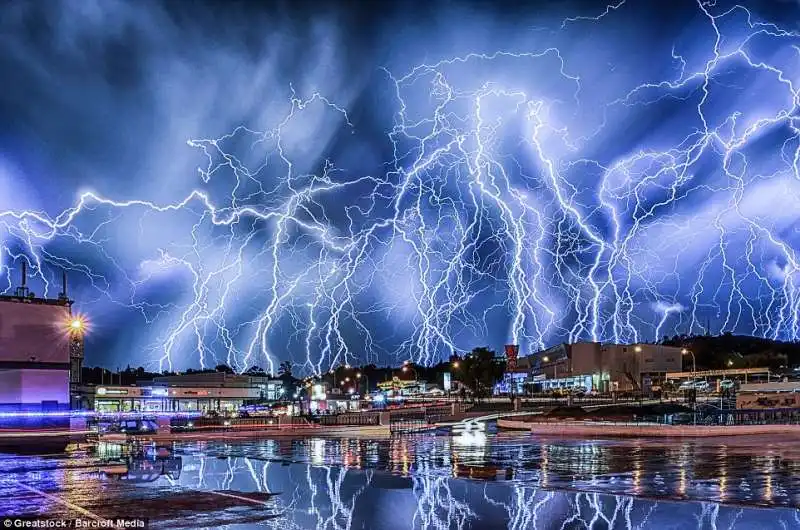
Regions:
[[529, 342, 683, 392]]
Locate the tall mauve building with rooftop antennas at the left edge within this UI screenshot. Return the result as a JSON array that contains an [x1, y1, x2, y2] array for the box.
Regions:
[[0, 268, 84, 411]]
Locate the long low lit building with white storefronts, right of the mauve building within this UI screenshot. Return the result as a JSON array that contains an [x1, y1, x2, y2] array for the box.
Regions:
[[89, 372, 291, 412]]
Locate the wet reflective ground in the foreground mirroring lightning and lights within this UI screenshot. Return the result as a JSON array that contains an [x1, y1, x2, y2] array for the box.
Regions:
[[0, 435, 800, 530]]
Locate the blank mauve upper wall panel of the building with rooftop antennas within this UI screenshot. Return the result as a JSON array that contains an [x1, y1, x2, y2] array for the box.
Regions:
[[0, 300, 70, 365]]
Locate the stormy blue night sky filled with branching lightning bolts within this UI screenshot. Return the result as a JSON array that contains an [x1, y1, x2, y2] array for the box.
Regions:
[[0, 0, 800, 372]]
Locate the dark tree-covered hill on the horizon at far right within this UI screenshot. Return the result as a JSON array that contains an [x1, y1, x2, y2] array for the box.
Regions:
[[662, 333, 800, 372]]
